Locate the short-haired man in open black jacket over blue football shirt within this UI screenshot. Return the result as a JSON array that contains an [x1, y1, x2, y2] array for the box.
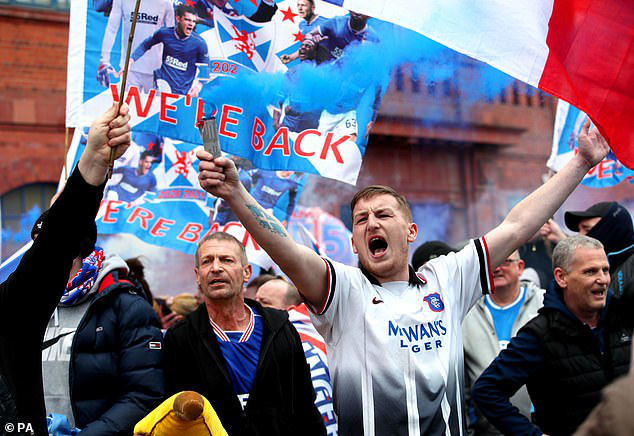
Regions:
[[163, 232, 326, 436]]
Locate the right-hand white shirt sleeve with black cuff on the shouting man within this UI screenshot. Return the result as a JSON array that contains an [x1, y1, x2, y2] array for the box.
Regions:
[[421, 236, 494, 320]]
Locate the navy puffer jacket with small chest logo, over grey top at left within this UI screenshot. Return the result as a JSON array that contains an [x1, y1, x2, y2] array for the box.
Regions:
[[70, 270, 165, 435]]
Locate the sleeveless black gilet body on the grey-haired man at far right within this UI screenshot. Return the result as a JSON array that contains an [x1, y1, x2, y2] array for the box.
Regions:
[[526, 293, 634, 435]]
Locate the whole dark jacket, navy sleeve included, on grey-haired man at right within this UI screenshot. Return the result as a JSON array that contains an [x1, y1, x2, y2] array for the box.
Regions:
[[473, 288, 634, 435]]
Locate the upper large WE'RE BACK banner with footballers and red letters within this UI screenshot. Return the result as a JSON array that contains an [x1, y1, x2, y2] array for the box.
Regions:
[[66, 0, 395, 184]]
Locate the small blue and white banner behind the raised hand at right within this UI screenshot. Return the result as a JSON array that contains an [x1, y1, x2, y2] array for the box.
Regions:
[[547, 100, 634, 188]]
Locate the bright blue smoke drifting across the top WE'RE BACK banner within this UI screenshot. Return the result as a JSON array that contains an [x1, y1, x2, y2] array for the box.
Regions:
[[201, 15, 514, 121]]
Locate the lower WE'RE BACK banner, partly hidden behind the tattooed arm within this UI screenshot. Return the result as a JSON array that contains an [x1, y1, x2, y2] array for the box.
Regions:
[[62, 123, 306, 269]]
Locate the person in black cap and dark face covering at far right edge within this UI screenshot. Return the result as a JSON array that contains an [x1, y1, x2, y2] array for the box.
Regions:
[[564, 201, 634, 296]]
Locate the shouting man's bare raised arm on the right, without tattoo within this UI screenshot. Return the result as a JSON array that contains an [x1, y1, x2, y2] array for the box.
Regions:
[[485, 120, 610, 268]]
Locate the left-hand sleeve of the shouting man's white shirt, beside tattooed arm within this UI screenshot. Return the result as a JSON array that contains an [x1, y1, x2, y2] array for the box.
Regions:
[[306, 259, 361, 344]]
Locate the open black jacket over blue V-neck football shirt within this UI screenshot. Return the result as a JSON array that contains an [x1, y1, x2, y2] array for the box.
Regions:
[[163, 300, 326, 436]]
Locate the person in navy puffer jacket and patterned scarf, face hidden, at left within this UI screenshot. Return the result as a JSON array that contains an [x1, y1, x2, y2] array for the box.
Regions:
[[42, 223, 164, 436]]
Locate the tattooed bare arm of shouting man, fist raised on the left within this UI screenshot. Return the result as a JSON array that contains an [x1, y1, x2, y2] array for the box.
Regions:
[[196, 150, 328, 308]]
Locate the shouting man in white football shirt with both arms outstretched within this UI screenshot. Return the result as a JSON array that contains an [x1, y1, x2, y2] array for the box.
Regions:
[[197, 123, 609, 435]]
